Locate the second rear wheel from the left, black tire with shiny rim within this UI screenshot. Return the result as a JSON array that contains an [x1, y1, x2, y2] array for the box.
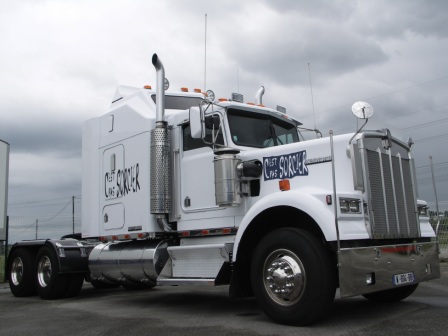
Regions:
[[35, 246, 69, 300]]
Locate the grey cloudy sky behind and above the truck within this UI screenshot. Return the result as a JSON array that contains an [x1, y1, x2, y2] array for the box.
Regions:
[[0, 0, 448, 224]]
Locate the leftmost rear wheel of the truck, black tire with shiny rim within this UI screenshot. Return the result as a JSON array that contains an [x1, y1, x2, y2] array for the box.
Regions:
[[8, 248, 36, 297]]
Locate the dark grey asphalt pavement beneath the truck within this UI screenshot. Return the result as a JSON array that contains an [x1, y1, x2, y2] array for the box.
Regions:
[[0, 262, 448, 336]]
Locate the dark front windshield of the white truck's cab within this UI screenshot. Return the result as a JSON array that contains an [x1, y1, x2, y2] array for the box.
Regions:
[[227, 108, 299, 148]]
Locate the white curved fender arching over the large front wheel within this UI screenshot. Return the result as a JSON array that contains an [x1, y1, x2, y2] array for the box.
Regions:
[[233, 188, 337, 261]]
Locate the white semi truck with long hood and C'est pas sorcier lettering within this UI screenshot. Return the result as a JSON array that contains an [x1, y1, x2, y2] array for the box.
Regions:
[[8, 54, 440, 325]]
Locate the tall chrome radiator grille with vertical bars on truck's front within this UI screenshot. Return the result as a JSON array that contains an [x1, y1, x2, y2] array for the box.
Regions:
[[366, 148, 419, 239]]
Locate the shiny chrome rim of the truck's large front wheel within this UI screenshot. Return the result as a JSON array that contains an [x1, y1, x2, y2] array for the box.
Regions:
[[263, 249, 306, 307]]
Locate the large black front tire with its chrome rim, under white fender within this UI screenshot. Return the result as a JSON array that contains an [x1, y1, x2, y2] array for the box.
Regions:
[[251, 228, 336, 326]]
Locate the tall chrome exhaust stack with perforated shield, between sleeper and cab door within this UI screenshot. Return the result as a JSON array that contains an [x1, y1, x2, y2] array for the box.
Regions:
[[150, 54, 172, 231]]
